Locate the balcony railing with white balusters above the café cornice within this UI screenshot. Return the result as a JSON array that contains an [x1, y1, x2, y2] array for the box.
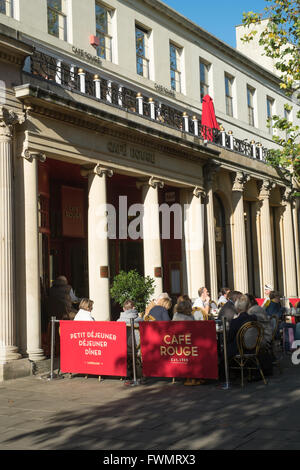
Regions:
[[24, 51, 268, 161]]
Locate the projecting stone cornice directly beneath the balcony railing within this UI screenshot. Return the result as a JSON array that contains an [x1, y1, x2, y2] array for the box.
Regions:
[[15, 85, 220, 163]]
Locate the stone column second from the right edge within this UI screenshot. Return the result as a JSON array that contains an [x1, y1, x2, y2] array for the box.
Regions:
[[259, 180, 276, 294]]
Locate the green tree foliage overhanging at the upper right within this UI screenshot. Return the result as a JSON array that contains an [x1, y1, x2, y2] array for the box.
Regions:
[[242, 0, 300, 182]]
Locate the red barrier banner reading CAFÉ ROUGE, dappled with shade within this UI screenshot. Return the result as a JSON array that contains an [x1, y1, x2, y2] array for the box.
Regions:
[[140, 321, 218, 379]]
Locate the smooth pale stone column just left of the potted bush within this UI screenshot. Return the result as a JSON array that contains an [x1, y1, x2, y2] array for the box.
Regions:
[[88, 165, 115, 321]]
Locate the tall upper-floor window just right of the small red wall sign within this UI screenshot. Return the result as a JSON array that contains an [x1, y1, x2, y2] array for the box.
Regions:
[[95, 2, 112, 61]]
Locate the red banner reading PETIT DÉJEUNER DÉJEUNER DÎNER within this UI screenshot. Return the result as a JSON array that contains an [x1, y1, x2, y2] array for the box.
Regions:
[[60, 321, 127, 377]]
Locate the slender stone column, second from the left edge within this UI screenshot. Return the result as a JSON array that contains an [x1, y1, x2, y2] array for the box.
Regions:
[[22, 150, 46, 361]]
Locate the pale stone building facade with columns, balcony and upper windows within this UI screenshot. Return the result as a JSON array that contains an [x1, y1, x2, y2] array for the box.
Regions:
[[0, 0, 300, 380]]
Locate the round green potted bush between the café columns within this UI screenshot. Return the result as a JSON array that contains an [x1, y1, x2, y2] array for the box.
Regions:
[[110, 270, 155, 313]]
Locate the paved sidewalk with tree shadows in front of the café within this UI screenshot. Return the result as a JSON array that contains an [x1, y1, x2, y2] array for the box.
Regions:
[[0, 357, 300, 450]]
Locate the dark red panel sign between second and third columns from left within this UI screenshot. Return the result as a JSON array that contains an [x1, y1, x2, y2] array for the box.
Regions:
[[61, 186, 85, 238]]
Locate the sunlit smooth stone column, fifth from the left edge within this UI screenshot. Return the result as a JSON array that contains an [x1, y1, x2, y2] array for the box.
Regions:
[[183, 187, 205, 299]]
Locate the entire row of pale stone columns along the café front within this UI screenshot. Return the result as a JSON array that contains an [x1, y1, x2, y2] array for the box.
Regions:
[[0, 107, 299, 364]]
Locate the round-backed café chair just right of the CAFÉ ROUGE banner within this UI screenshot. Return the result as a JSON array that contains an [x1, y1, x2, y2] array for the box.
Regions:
[[229, 321, 267, 387]]
